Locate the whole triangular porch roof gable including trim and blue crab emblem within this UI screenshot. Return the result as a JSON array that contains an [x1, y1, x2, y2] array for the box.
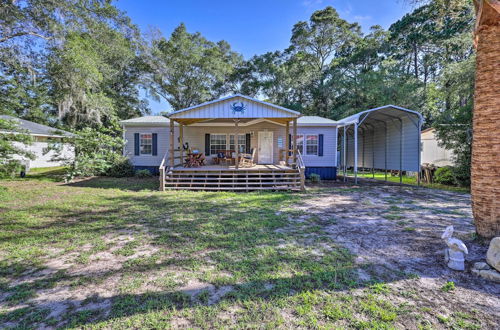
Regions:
[[169, 94, 300, 125]]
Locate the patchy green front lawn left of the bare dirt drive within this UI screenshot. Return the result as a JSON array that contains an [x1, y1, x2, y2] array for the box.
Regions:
[[0, 173, 484, 329]]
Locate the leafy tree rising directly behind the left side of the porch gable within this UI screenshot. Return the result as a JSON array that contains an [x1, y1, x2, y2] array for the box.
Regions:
[[148, 24, 242, 110]]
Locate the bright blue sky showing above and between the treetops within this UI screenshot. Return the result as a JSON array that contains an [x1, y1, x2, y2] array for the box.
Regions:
[[116, 0, 412, 113]]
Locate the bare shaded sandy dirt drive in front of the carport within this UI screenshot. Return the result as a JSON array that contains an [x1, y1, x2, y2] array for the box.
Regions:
[[282, 185, 500, 323]]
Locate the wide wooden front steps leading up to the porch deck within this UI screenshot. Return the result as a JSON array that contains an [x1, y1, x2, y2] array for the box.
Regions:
[[164, 168, 301, 191]]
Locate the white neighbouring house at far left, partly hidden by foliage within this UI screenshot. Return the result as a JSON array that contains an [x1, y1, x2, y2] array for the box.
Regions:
[[0, 115, 75, 169]]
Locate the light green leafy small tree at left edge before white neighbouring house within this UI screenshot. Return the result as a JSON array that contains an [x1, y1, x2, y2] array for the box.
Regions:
[[0, 118, 34, 177]]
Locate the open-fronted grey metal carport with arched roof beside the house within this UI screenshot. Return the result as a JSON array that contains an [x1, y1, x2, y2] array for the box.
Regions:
[[338, 105, 424, 184]]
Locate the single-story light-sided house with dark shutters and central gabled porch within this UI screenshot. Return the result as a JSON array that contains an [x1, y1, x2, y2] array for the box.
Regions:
[[121, 94, 422, 190]]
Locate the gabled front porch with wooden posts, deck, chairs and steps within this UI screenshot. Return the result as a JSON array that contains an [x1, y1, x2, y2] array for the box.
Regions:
[[160, 95, 305, 190]]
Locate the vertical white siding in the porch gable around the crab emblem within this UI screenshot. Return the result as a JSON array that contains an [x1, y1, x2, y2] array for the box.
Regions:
[[171, 97, 295, 118]]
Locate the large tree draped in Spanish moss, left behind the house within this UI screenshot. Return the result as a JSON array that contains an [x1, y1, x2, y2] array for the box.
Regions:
[[49, 23, 147, 128]]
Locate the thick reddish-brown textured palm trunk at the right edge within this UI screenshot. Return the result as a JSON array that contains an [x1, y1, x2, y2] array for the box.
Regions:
[[471, 0, 500, 237]]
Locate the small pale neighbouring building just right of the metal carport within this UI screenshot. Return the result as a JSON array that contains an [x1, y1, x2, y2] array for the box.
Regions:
[[421, 128, 453, 167]]
